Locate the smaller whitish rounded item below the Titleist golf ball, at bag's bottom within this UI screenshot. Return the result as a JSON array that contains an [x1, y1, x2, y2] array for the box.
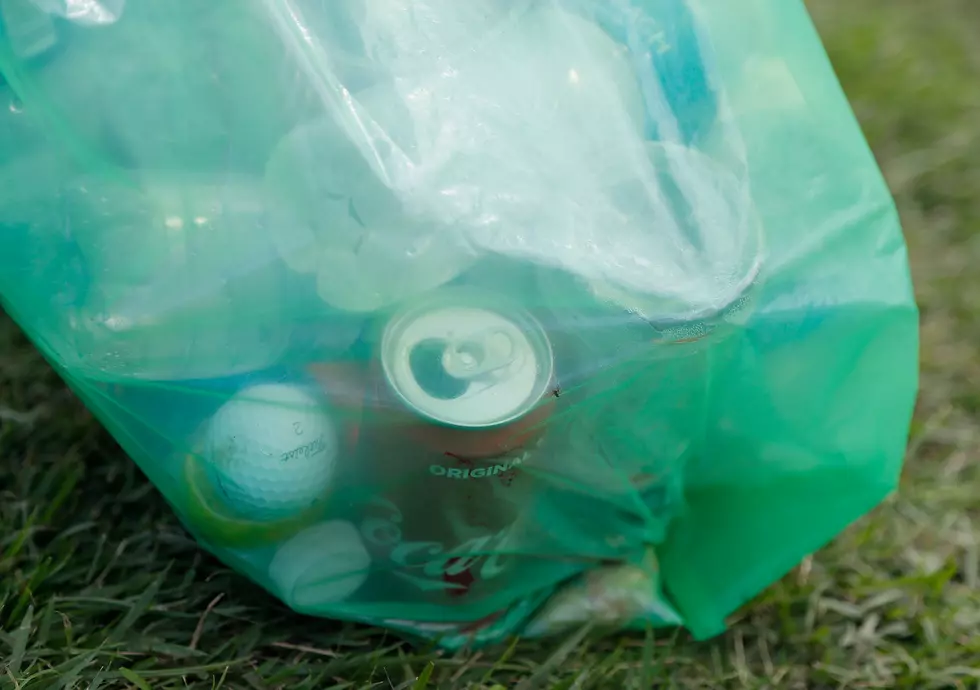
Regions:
[[269, 520, 371, 610]]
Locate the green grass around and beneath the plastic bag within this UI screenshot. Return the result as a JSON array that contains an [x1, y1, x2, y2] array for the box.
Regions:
[[0, 0, 980, 690]]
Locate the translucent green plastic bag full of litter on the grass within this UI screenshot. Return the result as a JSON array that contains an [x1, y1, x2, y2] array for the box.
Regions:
[[0, 0, 917, 647]]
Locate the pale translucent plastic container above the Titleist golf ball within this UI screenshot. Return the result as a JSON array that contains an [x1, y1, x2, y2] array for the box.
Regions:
[[66, 174, 322, 381]]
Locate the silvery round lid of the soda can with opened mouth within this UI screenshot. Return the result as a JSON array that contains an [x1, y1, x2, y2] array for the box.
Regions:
[[382, 295, 553, 428]]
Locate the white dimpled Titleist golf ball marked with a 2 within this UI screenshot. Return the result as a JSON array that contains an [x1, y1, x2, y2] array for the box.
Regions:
[[206, 384, 337, 521]]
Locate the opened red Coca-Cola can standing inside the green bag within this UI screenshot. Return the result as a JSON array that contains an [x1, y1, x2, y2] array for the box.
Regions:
[[362, 289, 555, 606]]
